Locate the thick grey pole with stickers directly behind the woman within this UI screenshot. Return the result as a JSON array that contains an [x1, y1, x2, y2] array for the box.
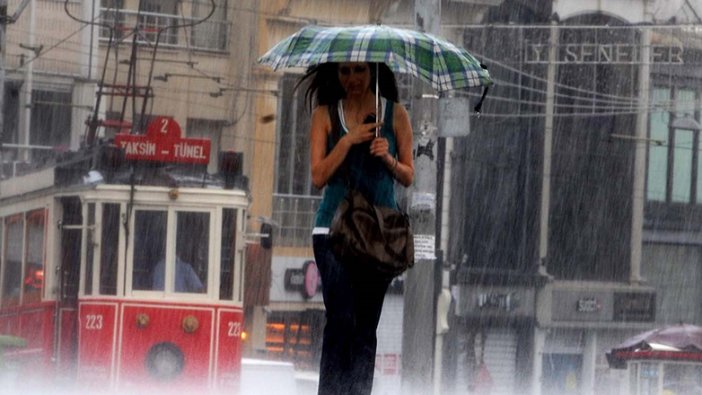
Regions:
[[402, 0, 441, 395]]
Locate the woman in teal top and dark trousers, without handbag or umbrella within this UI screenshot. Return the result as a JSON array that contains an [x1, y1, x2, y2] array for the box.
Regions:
[[300, 63, 414, 395]]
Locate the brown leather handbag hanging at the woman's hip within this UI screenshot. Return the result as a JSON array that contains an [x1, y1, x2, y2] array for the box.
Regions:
[[329, 189, 414, 277]]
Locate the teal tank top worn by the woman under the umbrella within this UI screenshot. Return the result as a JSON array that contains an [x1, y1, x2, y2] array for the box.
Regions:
[[314, 100, 397, 228]]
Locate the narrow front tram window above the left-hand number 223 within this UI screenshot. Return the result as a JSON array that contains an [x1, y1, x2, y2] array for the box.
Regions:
[[100, 203, 120, 295]]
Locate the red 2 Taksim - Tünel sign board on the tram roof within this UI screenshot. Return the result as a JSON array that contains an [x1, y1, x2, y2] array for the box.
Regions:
[[115, 117, 210, 165]]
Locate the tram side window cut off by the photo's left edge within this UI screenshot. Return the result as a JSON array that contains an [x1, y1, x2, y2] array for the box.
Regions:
[[0, 214, 24, 307]]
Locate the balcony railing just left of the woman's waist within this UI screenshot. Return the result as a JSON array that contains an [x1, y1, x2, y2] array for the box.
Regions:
[[273, 194, 322, 247]]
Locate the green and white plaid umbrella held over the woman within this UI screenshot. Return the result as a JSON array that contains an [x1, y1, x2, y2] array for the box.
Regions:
[[258, 25, 492, 91]]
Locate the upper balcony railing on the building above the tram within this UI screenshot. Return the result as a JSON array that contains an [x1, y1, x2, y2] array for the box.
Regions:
[[100, 8, 231, 52]]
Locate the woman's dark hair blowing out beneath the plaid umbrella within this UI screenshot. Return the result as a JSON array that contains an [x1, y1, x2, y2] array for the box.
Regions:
[[295, 63, 400, 110]]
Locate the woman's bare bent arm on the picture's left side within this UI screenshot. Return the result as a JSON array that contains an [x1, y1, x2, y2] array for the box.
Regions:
[[310, 106, 382, 188]]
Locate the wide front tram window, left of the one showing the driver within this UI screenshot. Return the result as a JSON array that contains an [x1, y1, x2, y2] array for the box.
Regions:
[[132, 210, 168, 291]]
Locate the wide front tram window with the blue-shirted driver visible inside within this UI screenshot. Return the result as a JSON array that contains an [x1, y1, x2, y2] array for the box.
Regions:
[[173, 211, 210, 293]]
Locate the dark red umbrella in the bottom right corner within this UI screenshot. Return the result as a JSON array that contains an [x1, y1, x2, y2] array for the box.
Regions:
[[607, 323, 702, 369]]
